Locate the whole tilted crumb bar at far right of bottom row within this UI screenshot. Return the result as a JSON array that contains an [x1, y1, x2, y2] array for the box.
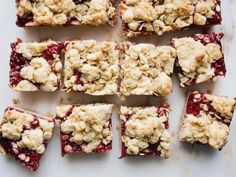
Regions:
[[179, 91, 236, 149]]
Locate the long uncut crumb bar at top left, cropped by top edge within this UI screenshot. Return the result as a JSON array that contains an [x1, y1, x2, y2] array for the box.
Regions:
[[16, 0, 117, 27]]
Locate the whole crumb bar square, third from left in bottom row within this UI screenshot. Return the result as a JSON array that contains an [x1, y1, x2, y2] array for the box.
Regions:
[[120, 104, 170, 158]]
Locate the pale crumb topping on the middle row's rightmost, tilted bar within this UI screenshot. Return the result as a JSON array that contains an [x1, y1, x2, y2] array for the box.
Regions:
[[173, 37, 224, 87]]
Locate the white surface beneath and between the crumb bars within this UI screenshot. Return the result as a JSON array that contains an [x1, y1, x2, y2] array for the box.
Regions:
[[0, 0, 236, 177]]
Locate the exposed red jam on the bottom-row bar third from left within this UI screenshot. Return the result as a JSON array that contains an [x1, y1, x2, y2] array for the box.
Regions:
[[120, 104, 170, 159]]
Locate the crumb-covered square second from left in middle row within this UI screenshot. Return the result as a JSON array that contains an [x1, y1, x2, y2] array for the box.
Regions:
[[64, 40, 119, 95]]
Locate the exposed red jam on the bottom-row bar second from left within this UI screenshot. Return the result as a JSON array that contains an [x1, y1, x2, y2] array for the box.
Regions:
[[58, 106, 112, 157]]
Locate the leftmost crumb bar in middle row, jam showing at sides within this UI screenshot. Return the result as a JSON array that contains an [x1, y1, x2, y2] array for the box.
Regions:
[[10, 40, 63, 92]]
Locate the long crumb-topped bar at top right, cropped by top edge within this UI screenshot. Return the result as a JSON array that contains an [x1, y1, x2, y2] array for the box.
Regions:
[[120, 0, 221, 37]]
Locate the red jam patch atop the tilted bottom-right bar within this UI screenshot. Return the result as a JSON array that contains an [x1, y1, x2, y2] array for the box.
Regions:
[[185, 92, 230, 125]]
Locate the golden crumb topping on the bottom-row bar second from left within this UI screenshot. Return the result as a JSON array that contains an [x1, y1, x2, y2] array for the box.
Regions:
[[57, 104, 113, 153]]
